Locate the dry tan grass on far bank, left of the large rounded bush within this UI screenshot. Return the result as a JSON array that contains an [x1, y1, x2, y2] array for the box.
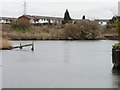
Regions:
[[2, 25, 64, 40]]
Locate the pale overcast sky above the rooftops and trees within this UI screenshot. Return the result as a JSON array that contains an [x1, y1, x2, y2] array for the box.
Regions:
[[0, 0, 119, 19]]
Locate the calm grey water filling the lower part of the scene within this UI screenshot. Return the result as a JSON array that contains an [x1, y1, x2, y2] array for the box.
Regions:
[[2, 40, 120, 88]]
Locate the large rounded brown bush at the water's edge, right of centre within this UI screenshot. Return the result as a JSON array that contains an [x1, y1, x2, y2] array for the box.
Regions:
[[64, 20, 102, 40]]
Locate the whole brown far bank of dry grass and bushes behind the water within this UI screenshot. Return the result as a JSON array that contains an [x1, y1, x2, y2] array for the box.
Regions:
[[2, 21, 117, 40]]
